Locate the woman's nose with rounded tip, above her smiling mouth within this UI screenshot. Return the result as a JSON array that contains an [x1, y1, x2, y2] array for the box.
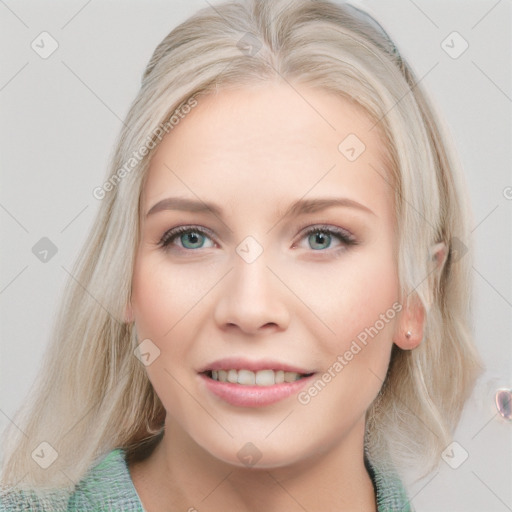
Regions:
[[214, 249, 290, 334]]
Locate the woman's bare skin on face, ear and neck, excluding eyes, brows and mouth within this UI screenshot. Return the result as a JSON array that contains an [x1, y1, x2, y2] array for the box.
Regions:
[[126, 83, 424, 512]]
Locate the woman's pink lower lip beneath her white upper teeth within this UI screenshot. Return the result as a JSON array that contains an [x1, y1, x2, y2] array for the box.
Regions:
[[200, 374, 315, 407]]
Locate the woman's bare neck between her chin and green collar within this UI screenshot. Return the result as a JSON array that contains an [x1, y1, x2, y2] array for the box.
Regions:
[[130, 422, 376, 512]]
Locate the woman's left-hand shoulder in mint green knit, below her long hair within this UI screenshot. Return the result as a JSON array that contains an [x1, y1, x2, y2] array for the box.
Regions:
[[0, 449, 144, 512]]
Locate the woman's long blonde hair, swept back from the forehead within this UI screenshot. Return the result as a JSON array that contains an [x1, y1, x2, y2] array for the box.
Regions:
[[2, 0, 480, 496]]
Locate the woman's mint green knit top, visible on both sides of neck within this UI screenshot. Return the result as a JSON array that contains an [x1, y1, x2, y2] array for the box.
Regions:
[[0, 449, 412, 512]]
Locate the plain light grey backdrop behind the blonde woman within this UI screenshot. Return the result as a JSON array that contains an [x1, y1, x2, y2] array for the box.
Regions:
[[0, 0, 512, 512]]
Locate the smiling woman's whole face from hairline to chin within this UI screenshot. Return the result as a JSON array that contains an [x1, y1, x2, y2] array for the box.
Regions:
[[131, 84, 401, 467]]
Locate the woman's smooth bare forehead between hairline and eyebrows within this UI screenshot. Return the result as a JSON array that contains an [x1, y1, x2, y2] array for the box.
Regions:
[[143, 83, 392, 220]]
